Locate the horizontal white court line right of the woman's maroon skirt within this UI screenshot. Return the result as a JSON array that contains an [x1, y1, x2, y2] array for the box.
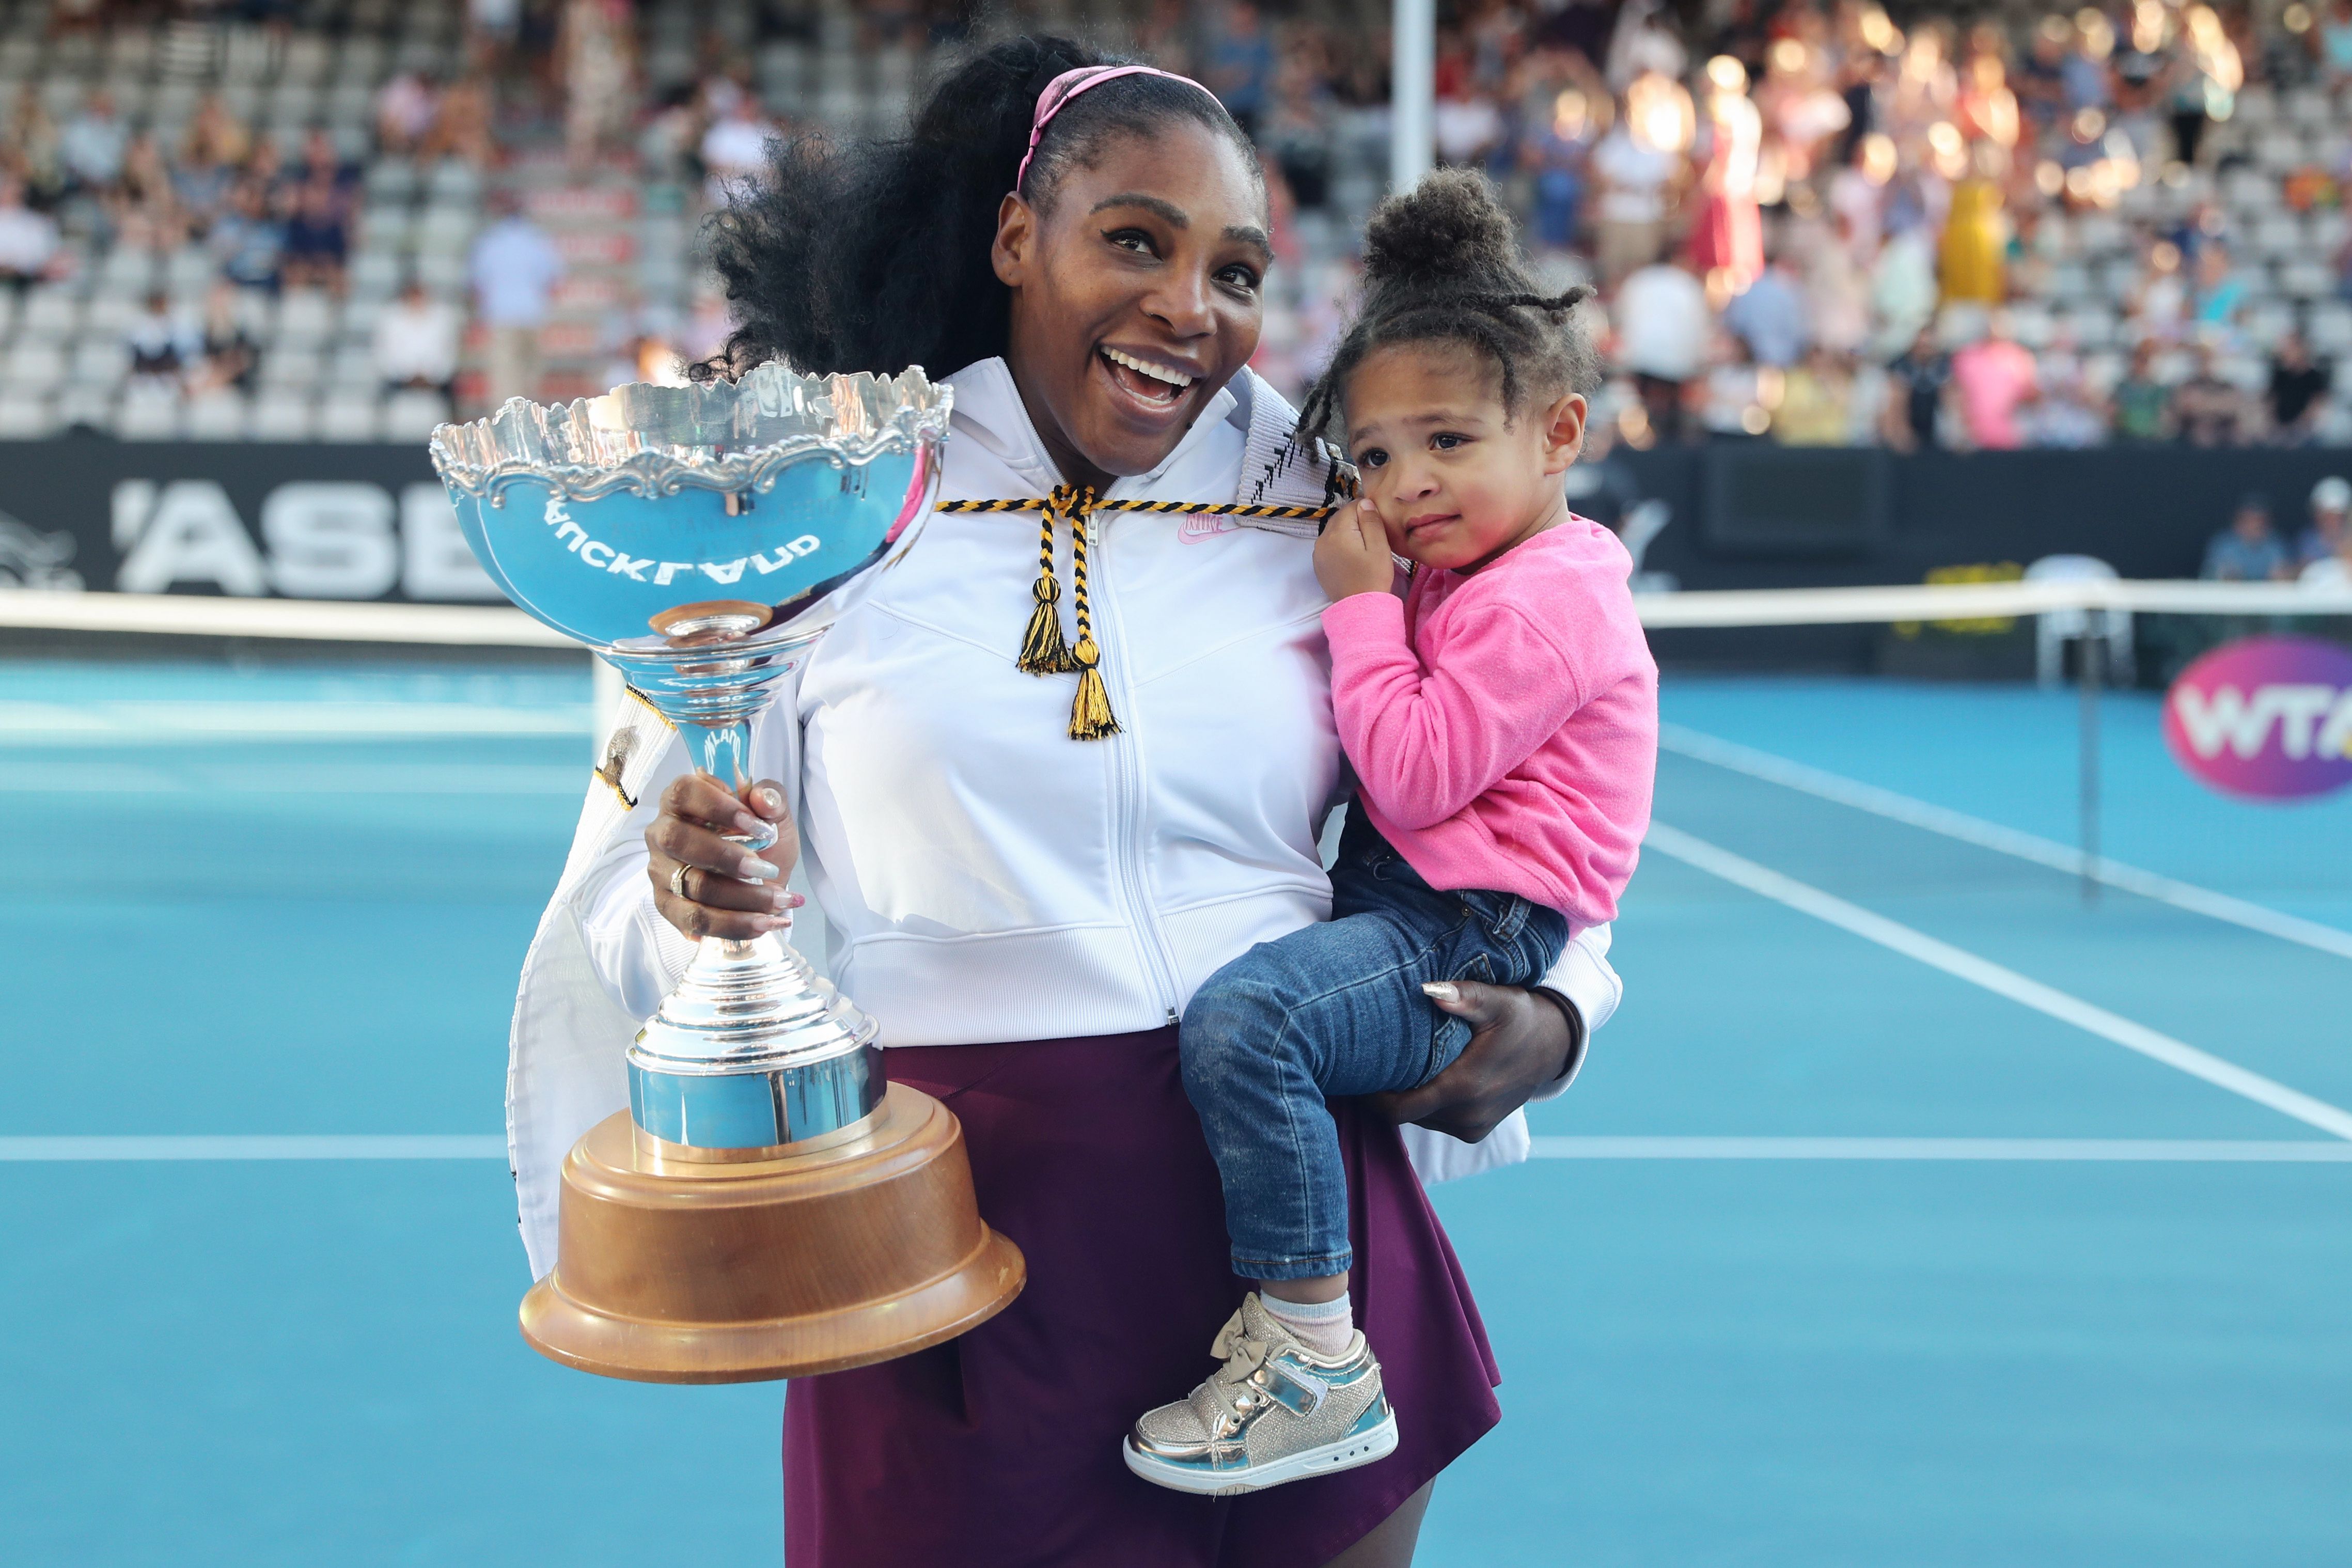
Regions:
[[1529, 1138, 2352, 1166]]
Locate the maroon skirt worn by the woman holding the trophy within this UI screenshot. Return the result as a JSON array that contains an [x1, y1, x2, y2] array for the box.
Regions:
[[783, 1030, 1500, 1568]]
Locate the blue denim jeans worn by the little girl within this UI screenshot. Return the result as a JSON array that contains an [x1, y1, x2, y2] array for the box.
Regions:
[[1181, 811, 1569, 1279]]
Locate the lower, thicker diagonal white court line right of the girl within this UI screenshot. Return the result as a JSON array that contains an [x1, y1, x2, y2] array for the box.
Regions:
[[1647, 821, 2352, 1138]]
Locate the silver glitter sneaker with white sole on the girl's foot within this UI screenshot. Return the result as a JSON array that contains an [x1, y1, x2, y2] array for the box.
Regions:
[[1120, 1293, 1397, 1497]]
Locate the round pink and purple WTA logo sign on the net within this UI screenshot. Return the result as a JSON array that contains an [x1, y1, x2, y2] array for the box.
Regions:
[[2164, 637, 2352, 799]]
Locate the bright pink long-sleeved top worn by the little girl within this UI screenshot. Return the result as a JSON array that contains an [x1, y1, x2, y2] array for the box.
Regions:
[[1324, 517, 1658, 929]]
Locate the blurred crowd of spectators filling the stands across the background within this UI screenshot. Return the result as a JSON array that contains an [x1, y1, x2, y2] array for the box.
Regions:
[[13, 0, 2352, 449]]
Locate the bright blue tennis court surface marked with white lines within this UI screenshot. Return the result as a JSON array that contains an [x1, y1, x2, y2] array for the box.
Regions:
[[0, 661, 2352, 1568]]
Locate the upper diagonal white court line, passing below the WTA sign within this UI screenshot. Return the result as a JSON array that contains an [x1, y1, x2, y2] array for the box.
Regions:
[[1658, 724, 2352, 959]]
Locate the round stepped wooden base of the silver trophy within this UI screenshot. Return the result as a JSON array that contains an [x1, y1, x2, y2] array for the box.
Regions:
[[522, 1084, 1028, 1382]]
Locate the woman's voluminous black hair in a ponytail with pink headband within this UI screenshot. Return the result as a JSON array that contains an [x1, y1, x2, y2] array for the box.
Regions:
[[696, 38, 1263, 376]]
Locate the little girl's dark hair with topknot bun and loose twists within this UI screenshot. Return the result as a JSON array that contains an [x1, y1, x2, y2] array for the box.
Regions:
[[1298, 169, 1602, 437]]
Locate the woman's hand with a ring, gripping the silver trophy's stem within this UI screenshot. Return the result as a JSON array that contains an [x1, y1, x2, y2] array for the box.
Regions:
[[645, 774, 802, 940]]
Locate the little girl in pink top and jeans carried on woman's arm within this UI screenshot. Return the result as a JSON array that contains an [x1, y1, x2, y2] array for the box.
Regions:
[[1124, 171, 1658, 1495]]
